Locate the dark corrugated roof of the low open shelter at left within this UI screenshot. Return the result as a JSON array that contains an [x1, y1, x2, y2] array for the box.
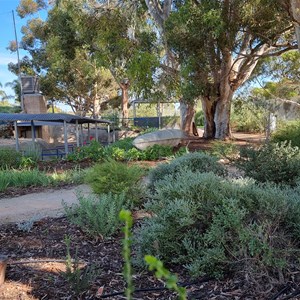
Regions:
[[0, 113, 111, 124]]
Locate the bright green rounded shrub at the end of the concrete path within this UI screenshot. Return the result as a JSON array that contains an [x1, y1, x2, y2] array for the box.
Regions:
[[86, 160, 144, 206]]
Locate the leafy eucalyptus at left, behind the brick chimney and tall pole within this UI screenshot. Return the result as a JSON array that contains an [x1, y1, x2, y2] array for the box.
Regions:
[[10, 0, 117, 117]]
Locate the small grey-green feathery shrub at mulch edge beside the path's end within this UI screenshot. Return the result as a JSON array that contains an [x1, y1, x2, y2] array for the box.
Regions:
[[63, 193, 126, 239]]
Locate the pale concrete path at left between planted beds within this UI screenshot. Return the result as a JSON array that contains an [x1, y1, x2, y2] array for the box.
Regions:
[[0, 185, 91, 224]]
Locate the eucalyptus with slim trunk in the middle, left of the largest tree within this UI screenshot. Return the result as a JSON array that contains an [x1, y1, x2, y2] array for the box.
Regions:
[[77, 0, 161, 125]]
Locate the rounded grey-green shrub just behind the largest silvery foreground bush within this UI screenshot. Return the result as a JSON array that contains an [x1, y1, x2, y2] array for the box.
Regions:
[[149, 152, 226, 186]]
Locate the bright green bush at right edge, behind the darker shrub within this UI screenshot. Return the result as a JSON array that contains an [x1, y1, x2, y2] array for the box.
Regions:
[[271, 120, 300, 148]]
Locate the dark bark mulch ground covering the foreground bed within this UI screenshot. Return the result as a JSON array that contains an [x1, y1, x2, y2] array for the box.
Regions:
[[0, 217, 300, 300]]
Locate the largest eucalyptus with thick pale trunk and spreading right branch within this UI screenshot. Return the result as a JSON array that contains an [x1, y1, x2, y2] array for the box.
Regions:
[[164, 0, 297, 139]]
